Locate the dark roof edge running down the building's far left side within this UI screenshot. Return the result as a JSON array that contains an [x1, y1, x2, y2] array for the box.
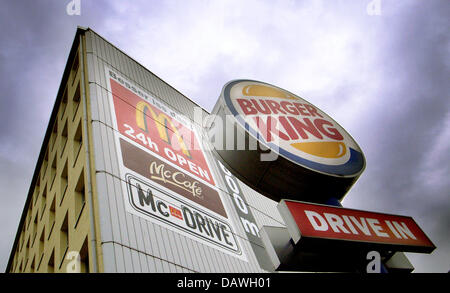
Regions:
[[5, 26, 88, 273]]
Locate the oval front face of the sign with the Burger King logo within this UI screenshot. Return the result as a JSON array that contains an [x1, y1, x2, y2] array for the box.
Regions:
[[223, 80, 365, 177]]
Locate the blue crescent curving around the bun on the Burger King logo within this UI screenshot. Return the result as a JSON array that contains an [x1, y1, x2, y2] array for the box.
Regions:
[[223, 79, 364, 176]]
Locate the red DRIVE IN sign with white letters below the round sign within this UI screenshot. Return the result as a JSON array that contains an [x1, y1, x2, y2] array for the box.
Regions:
[[278, 200, 435, 252]]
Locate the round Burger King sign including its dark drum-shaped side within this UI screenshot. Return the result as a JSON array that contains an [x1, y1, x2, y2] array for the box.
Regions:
[[213, 80, 365, 202]]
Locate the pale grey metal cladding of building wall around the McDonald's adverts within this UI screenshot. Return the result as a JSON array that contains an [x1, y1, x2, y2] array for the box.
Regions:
[[82, 30, 276, 273]]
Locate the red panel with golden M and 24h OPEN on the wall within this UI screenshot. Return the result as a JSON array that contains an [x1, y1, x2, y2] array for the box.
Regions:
[[110, 78, 215, 185]]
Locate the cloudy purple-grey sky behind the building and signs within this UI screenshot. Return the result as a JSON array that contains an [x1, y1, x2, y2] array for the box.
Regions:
[[0, 0, 450, 272]]
